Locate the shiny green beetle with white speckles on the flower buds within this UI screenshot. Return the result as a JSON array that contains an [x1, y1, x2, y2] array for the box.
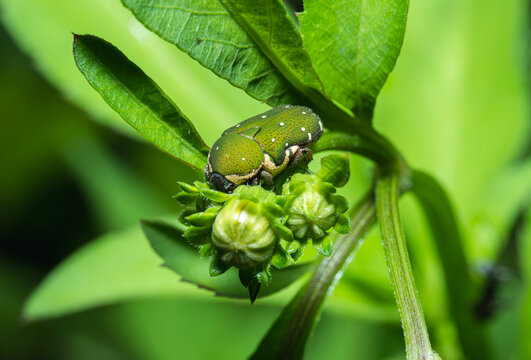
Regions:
[[205, 105, 323, 193]]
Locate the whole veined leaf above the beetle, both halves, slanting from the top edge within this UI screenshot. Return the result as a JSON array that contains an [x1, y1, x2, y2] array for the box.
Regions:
[[122, 0, 359, 130]]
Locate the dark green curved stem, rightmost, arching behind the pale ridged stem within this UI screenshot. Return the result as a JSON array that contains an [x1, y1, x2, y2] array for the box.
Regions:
[[411, 171, 492, 360]]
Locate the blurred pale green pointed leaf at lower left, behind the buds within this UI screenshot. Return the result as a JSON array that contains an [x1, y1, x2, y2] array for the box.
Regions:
[[22, 226, 194, 321]]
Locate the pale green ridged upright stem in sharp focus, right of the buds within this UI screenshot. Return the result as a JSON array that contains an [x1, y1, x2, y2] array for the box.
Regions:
[[376, 171, 439, 360]]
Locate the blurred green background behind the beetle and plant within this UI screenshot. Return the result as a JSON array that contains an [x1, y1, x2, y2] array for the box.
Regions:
[[0, 0, 531, 360]]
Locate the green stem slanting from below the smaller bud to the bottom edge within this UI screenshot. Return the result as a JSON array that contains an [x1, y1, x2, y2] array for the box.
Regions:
[[251, 190, 376, 360]]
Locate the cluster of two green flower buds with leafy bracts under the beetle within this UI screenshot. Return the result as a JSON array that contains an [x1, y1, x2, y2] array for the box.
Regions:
[[175, 155, 350, 300]]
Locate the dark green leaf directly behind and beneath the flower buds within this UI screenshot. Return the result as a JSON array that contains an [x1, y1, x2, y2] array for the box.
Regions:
[[143, 221, 315, 299]]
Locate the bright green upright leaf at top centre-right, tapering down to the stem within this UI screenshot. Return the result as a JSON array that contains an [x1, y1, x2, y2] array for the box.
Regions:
[[300, 0, 408, 119]]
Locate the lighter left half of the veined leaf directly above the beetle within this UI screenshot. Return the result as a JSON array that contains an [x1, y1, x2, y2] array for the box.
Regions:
[[122, 0, 302, 105]]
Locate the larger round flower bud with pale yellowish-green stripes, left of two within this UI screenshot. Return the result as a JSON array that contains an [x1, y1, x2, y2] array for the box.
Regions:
[[212, 197, 278, 269]]
